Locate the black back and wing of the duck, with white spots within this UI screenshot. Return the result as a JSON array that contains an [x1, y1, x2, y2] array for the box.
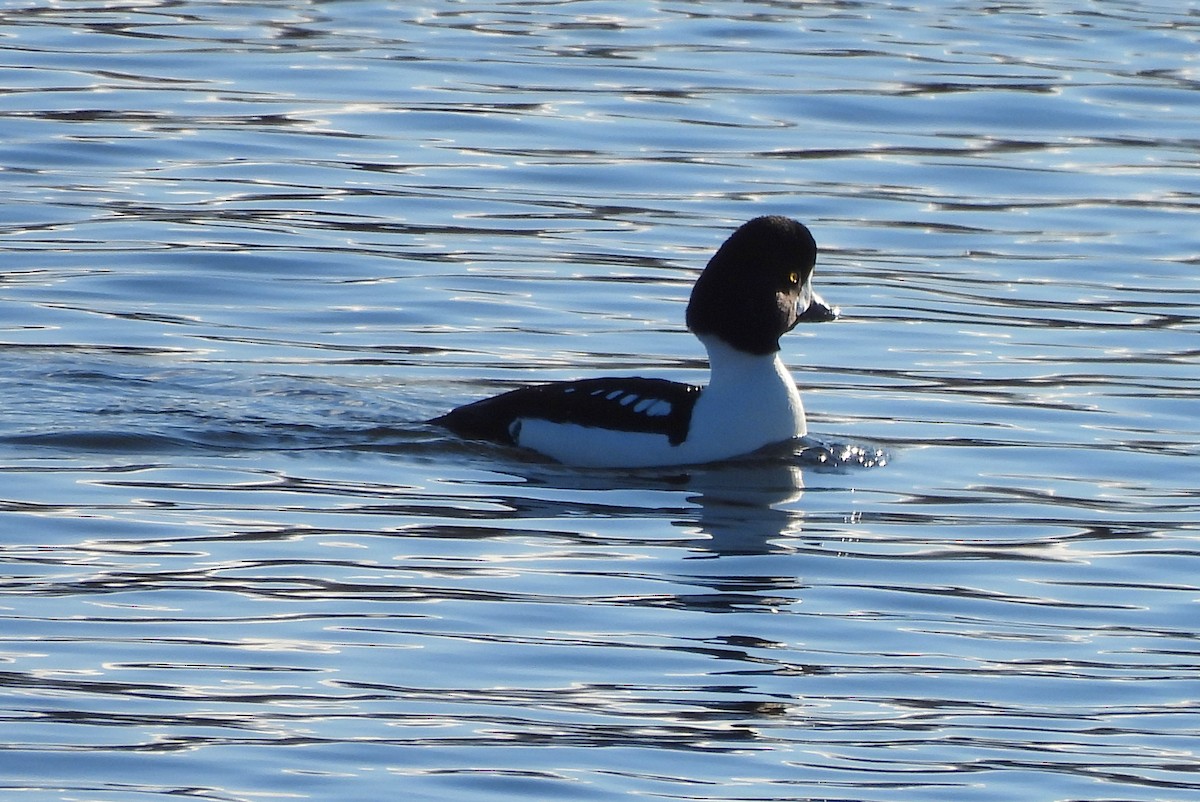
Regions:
[[431, 376, 701, 445]]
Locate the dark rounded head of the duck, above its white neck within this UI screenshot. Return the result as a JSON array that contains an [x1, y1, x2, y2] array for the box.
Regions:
[[688, 216, 828, 354]]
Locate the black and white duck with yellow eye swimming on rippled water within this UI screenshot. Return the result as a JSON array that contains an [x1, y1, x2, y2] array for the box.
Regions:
[[433, 217, 836, 467]]
